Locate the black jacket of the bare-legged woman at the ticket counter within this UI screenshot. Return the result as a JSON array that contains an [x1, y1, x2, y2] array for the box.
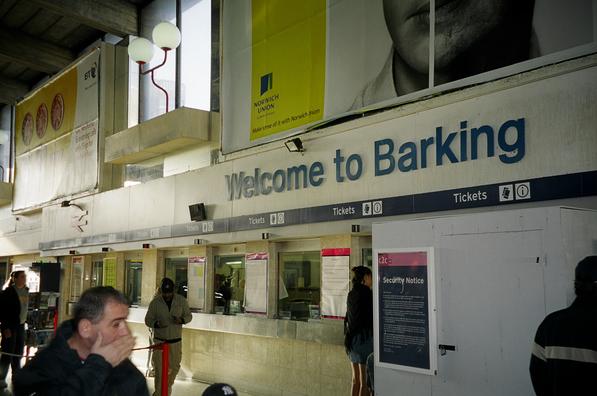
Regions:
[[344, 284, 373, 351]]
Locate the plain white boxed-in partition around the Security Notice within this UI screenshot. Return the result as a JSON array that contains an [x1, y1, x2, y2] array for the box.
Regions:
[[373, 207, 597, 396]]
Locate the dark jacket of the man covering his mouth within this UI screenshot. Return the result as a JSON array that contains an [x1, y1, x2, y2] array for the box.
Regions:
[[13, 321, 149, 396]]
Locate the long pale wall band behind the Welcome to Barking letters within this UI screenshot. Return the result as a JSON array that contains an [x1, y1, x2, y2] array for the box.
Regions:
[[42, 57, 597, 248]]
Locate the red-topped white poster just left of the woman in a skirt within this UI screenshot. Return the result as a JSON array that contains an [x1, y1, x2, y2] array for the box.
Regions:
[[321, 248, 350, 319]]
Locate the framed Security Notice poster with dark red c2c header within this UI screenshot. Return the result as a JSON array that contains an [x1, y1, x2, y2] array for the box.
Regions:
[[375, 248, 437, 374]]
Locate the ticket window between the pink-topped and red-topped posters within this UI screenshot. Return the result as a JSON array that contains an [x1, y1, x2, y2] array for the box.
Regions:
[[278, 251, 321, 321]]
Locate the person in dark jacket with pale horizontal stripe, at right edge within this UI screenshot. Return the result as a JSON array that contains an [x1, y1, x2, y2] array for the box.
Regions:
[[530, 256, 597, 396]]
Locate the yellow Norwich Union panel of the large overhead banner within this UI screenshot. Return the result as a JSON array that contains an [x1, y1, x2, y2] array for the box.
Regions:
[[251, 0, 326, 140]]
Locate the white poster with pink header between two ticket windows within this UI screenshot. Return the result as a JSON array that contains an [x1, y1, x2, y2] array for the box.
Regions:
[[245, 252, 268, 315]]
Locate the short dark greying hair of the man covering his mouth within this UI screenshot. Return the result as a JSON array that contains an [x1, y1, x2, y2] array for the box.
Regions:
[[73, 286, 129, 330]]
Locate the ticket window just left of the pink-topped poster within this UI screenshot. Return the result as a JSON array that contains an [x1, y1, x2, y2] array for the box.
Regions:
[[214, 256, 245, 315]]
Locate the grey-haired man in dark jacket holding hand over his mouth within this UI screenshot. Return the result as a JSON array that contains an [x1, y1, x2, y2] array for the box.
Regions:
[[13, 286, 149, 396]]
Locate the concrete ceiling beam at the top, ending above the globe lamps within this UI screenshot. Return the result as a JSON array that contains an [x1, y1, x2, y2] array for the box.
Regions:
[[29, 0, 139, 37]]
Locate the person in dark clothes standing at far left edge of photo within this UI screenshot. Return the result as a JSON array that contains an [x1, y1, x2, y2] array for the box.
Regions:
[[0, 271, 29, 392]]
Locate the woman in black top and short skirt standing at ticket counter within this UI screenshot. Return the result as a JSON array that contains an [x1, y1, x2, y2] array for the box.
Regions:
[[344, 265, 373, 396]]
